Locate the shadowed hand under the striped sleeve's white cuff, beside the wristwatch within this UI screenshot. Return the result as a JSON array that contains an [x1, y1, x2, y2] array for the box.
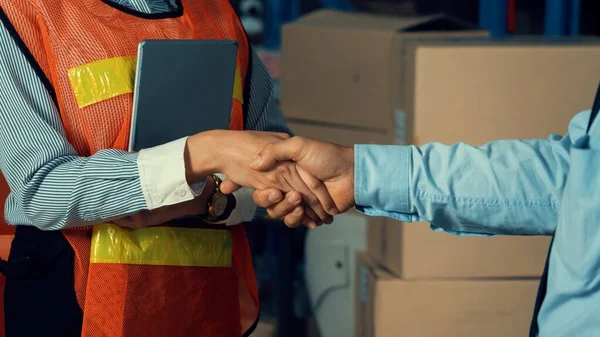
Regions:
[[112, 179, 215, 228]]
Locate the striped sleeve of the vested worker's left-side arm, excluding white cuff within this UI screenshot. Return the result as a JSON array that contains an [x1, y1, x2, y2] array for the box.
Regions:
[[0, 25, 146, 230]]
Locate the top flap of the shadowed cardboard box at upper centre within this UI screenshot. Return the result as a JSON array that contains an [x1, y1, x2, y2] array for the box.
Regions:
[[292, 10, 478, 32]]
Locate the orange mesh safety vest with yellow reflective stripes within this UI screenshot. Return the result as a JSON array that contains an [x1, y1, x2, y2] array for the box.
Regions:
[[0, 0, 258, 337]]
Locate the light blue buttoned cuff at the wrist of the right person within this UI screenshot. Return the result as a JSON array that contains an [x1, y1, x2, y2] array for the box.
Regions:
[[354, 145, 412, 214]]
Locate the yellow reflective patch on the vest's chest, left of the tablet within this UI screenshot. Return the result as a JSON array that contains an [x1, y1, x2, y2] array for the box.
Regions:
[[69, 56, 137, 108]]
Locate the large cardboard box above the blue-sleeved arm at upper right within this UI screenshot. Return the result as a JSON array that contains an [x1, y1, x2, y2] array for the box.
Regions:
[[401, 38, 600, 145]]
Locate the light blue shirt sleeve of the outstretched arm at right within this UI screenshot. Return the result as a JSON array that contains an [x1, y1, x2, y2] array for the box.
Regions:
[[354, 111, 589, 235]]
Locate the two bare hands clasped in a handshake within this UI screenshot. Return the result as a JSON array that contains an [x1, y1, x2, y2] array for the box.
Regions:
[[186, 130, 354, 228]]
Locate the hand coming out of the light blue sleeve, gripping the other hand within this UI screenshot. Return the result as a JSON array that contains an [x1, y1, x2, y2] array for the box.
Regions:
[[244, 137, 355, 227]]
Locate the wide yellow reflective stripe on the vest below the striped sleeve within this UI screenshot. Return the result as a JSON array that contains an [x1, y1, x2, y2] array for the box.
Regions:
[[90, 224, 233, 267]]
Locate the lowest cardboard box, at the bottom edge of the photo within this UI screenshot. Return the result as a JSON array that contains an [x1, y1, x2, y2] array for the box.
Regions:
[[355, 253, 539, 337]]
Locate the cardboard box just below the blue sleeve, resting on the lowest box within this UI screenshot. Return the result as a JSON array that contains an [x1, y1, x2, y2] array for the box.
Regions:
[[367, 219, 550, 279]]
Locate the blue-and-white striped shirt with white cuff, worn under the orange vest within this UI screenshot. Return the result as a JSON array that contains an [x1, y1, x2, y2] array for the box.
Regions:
[[0, 0, 289, 230]]
